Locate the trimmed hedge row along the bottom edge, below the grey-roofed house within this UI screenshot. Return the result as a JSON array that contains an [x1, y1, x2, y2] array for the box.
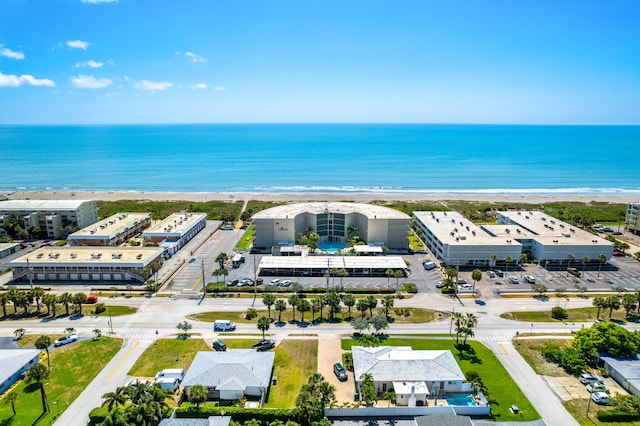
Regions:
[[176, 405, 296, 424]]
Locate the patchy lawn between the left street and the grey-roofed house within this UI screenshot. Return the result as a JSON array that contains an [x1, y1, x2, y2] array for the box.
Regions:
[[128, 337, 212, 377]]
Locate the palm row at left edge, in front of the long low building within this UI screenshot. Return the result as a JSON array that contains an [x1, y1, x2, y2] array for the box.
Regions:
[[0, 286, 87, 317]]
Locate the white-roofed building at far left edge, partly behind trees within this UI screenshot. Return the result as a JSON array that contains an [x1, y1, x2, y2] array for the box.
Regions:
[[0, 200, 98, 238]]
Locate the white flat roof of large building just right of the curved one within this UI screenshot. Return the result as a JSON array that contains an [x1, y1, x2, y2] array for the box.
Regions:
[[413, 211, 520, 246]]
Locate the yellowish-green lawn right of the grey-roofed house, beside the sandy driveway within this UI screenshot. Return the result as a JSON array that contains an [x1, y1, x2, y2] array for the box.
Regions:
[[262, 340, 318, 408]]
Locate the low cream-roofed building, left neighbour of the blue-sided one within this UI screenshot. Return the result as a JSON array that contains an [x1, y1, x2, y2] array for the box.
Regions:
[[67, 213, 151, 246]]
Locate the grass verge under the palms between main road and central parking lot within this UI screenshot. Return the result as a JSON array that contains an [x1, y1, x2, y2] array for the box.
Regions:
[[182, 307, 438, 330]]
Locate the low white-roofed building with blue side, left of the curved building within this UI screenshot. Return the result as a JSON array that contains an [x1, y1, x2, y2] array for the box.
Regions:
[[142, 213, 207, 255]]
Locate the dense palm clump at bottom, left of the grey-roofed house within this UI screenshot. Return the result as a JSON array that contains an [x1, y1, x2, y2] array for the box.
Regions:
[[101, 382, 169, 426]]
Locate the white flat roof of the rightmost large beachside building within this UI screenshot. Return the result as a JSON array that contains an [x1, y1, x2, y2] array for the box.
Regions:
[[497, 210, 613, 246]]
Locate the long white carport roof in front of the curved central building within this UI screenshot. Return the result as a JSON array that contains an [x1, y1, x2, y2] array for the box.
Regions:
[[258, 256, 407, 269]]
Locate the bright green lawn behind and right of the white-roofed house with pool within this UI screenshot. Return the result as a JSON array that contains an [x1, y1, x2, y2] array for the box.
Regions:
[[342, 338, 540, 422]]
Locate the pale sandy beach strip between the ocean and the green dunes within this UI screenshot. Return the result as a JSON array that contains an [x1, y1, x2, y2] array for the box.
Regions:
[[7, 191, 640, 204]]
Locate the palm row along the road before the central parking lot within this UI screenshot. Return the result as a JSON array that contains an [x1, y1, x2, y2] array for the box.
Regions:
[[262, 290, 394, 323]]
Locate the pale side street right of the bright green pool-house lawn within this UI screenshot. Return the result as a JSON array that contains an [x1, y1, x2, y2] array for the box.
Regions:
[[485, 342, 578, 426]]
